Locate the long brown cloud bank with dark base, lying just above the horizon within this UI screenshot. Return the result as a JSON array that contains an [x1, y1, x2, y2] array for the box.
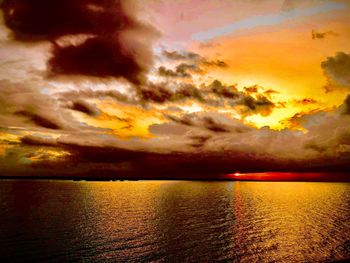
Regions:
[[7, 94, 350, 178]]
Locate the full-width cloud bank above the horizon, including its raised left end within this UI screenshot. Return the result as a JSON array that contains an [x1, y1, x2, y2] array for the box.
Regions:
[[1, 77, 350, 177]]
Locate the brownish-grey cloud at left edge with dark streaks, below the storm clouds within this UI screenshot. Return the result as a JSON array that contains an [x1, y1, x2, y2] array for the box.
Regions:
[[0, 80, 109, 133]]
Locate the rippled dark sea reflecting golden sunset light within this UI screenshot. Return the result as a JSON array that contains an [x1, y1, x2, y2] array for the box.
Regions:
[[0, 180, 350, 262]]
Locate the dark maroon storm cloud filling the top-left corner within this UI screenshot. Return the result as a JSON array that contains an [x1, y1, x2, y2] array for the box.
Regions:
[[2, 0, 108, 41]]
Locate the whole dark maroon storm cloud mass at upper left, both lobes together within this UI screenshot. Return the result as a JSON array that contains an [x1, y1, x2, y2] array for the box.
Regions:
[[1, 0, 158, 84]]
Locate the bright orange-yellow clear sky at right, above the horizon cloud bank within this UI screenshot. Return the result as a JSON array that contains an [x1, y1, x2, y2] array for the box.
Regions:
[[187, 9, 350, 128]]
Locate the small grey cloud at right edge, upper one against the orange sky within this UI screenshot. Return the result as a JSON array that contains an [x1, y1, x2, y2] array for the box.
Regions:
[[321, 52, 350, 91]]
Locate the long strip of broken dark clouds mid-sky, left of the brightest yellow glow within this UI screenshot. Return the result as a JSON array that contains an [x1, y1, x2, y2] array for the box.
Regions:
[[136, 80, 278, 116]]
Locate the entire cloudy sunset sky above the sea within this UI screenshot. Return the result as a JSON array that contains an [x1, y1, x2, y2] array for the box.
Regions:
[[0, 0, 350, 179]]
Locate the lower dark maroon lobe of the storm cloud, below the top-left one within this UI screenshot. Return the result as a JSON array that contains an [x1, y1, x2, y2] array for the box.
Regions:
[[49, 37, 143, 83]]
